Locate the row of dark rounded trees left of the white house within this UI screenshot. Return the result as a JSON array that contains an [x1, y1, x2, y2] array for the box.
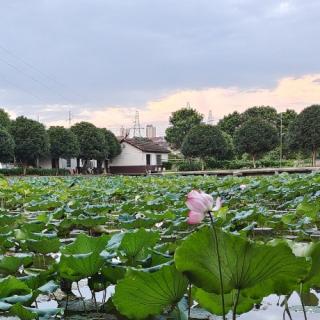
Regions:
[[0, 109, 121, 171]]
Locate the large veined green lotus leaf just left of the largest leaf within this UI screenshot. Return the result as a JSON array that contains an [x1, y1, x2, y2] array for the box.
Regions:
[[112, 265, 188, 319]]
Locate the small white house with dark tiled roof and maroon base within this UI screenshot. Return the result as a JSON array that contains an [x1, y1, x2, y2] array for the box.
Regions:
[[109, 138, 169, 174]]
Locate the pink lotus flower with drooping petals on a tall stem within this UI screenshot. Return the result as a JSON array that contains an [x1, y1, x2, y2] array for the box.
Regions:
[[186, 190, 222, 224]]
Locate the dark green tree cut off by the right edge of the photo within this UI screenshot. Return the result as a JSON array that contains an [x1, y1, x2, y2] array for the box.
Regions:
[[289, 105, 320, 166]]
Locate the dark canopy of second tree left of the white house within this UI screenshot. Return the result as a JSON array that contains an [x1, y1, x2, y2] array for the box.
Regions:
[[71, 121, 108, 160]]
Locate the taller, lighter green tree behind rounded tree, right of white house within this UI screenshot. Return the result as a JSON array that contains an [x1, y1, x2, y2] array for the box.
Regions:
[[166, 108, 203, 149]]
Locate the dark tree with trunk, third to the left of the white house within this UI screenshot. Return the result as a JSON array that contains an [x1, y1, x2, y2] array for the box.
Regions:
[[48, 126, 80, 168]]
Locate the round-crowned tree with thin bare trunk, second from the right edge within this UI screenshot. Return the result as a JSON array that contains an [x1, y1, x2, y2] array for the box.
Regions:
[[234, 118, 279, 167]]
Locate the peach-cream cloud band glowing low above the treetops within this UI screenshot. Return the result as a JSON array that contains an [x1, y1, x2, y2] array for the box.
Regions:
[[43, 74, 320, 134]]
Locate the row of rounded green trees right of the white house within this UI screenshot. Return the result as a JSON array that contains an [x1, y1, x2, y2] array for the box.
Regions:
[[166, 105, 320, 167]]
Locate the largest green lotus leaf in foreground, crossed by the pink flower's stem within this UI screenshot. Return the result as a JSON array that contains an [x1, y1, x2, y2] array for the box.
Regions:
[[175, 226, 309, 298]]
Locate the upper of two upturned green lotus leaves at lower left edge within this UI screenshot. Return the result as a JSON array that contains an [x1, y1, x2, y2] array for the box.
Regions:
[[0, 253, 33, 274]]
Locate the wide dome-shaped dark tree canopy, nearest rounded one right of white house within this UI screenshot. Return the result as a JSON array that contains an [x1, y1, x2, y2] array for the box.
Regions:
[[181, 124, 229, 159]]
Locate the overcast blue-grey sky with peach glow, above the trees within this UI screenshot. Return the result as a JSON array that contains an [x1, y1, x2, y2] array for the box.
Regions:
[[0, 0, 320, 134]]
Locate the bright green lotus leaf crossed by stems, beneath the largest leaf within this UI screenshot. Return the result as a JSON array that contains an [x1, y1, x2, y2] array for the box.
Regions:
[[193, 288, 262, 315]]
